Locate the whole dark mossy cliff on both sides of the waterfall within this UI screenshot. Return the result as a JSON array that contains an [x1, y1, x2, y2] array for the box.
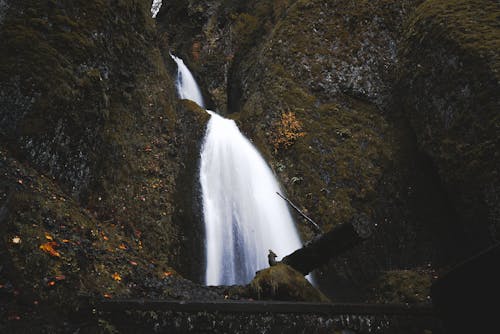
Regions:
[[0, 0, 500, 332]]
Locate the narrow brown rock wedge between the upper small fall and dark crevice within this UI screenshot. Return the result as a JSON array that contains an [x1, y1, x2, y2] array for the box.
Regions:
[[158, 0, 238, 112]]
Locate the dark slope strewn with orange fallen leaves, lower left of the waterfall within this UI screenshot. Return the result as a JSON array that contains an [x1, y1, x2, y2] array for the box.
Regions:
[[0, 149, 135, 317]]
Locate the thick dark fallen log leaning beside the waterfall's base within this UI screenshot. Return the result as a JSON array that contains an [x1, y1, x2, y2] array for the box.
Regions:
[[281, 215, 373, 275]]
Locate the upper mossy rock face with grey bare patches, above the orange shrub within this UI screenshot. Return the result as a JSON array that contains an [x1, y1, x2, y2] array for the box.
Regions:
[[232, 0, 419, 113]]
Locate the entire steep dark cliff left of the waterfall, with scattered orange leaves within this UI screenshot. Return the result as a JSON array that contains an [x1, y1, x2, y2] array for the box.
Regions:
[[0, 0, 207, 331]]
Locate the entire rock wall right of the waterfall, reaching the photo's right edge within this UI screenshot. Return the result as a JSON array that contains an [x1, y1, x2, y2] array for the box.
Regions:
[[159, 0, 498, 298]]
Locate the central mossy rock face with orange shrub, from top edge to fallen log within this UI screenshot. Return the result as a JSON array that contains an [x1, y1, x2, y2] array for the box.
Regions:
[[232, 1, 448, 298]]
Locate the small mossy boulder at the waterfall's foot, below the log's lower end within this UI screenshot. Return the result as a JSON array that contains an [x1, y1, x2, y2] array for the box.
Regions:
[[248, 263, 330, 302]]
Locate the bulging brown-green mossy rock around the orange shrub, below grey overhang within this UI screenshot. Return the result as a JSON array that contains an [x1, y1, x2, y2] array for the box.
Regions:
[[241, 62, 393, 235]]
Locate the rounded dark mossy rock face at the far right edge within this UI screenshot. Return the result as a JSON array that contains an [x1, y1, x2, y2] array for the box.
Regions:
[[399, 0, 500, 251]]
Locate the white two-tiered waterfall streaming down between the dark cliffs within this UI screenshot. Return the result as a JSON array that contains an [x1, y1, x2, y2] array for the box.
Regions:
[[172, 56, 301, 285]]
